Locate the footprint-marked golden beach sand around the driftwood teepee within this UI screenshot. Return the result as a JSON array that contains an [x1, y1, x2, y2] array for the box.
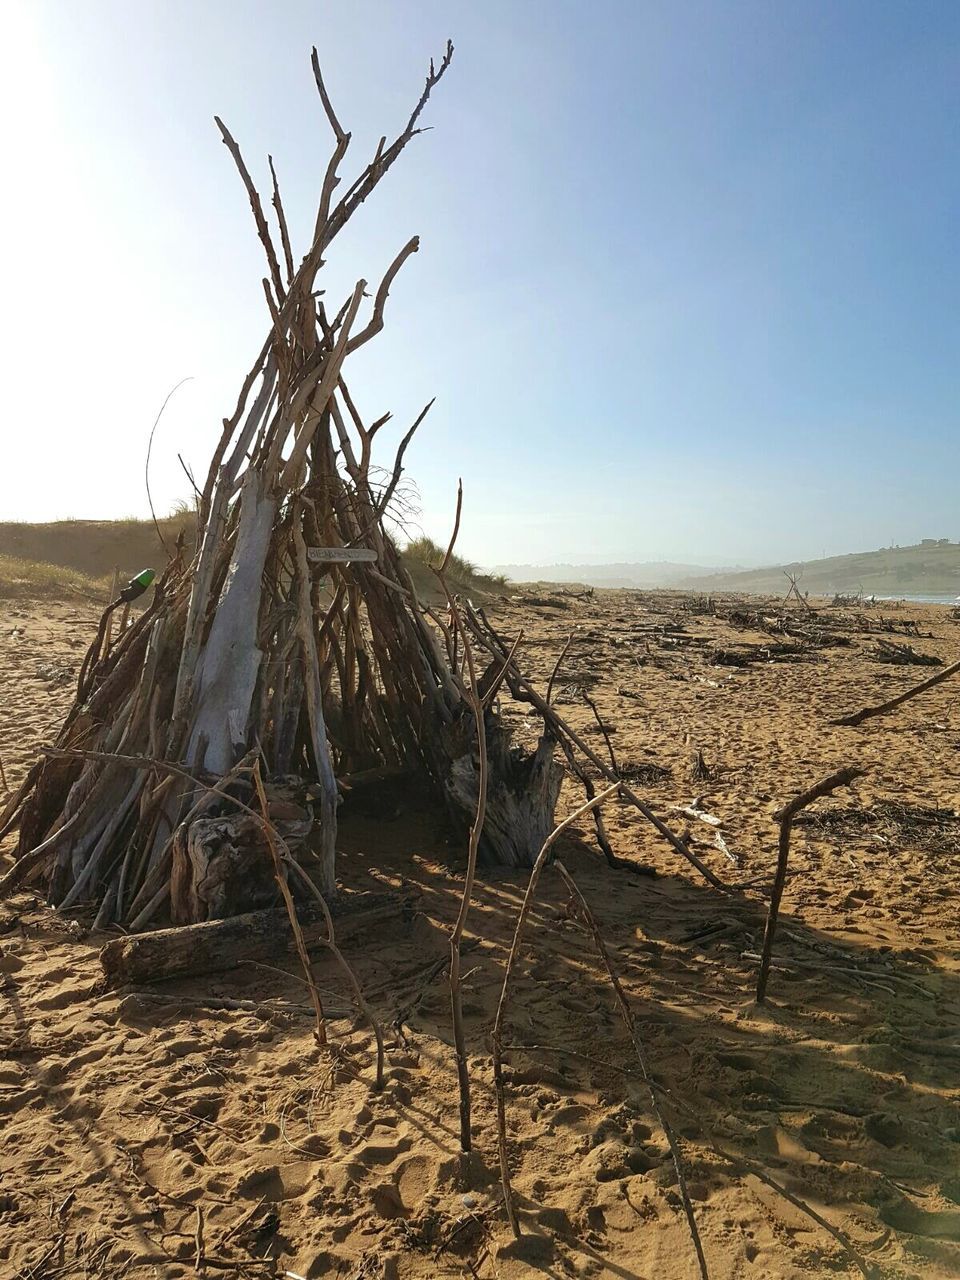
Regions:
[[0, 591, 960, 1280]]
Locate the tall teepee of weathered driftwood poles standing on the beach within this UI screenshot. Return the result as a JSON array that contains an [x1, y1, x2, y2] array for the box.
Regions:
[[0, 37, 568, 931]]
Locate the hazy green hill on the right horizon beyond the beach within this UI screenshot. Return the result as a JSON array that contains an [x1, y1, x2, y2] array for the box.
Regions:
[[672, 539, 960, 596]]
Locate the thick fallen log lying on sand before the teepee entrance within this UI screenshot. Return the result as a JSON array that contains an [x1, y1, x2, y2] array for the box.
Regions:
[[100, 893, 416, 987]]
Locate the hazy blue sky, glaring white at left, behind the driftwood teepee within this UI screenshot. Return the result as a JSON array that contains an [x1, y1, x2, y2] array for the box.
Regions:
[[0, 0, 960, 563]]
